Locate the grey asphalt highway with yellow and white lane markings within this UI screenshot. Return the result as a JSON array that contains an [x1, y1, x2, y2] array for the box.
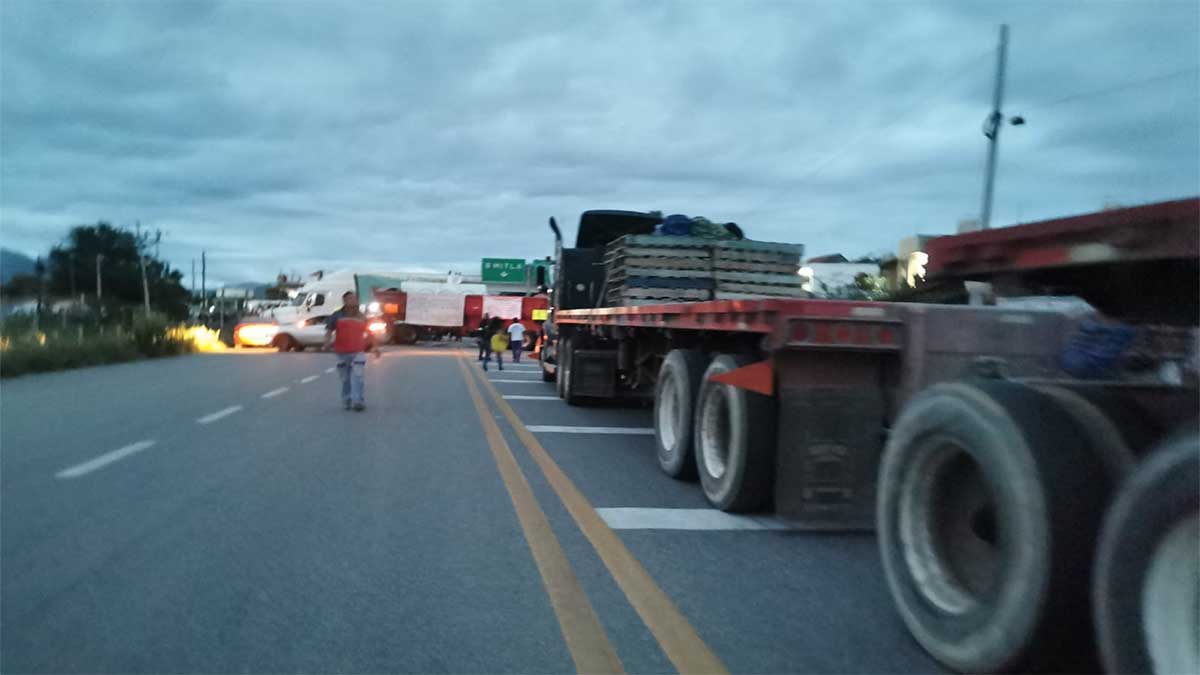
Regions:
[[0, 345, 941, 673]]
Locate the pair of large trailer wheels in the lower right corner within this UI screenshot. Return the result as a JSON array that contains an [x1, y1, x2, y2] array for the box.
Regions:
[[876, 381, 1200, 673]]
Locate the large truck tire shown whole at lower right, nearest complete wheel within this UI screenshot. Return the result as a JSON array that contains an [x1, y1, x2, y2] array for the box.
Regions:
[[876, 381, 1110, 673]]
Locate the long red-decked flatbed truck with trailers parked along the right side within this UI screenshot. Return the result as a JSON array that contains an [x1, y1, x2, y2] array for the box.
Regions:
[[540, 198, 1200, 673]]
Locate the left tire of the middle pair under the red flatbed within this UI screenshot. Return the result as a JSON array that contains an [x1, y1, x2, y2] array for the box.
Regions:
[[654, 350, 706, 480]]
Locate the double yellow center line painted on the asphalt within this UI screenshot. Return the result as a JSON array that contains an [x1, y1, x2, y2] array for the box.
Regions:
[[458, 359, 727, 674]]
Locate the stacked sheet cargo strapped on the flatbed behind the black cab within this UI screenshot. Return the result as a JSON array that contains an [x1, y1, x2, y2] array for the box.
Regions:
[[604, 234, 805, 306]]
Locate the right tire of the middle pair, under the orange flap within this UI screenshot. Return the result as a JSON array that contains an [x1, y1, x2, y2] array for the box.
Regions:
[[692, 354, 775, 512]]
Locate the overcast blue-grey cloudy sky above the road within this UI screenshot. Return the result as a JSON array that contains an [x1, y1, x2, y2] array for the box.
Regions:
[[0, 0, 1200, 282]]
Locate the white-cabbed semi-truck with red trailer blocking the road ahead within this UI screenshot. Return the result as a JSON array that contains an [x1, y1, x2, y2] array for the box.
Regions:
[[234, 271, 548, 352]]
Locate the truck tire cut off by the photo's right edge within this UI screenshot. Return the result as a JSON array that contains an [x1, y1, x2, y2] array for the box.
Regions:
[[1092, 434, 1200, 673]]
